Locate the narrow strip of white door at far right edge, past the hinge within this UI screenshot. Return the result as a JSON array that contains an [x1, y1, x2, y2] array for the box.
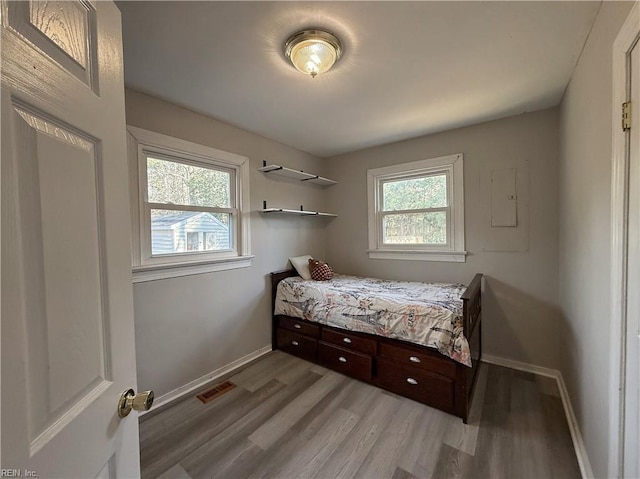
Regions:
[[624, 43, 640, 478]]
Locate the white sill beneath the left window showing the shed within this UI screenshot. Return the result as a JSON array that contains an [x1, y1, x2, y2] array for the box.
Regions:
[[132, 256, 254, 283]]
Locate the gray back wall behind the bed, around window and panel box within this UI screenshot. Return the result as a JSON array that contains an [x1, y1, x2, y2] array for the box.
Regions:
[[327, 109, 564, 368]]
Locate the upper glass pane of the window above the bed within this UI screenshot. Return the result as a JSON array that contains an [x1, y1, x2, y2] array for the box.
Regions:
[[382, 174, 449, 211]]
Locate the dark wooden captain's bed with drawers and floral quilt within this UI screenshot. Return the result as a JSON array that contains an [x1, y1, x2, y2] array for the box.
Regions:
[[271, 269, 482, 423]]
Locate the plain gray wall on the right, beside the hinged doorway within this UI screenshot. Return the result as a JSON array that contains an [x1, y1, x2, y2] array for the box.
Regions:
[[559, 2, 632, 477]]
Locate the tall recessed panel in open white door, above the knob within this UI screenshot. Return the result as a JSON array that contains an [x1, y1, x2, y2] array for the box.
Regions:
[[11, 101, 111, 456]]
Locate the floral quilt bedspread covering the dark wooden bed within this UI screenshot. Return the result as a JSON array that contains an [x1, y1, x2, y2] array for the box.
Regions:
[[275, 275, 471, 367]]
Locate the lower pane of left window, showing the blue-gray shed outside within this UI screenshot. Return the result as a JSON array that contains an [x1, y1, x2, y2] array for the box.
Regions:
[[151, 210, 231, 255]]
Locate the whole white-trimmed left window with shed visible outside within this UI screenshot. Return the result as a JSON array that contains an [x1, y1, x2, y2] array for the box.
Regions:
[[128, 127, 252, 281]]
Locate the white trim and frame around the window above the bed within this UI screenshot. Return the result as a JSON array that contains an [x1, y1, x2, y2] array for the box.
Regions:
[[367, 153, 467, 263]]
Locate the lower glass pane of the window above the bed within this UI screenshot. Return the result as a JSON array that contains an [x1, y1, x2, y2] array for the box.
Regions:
[[382, 211, 447, 244]]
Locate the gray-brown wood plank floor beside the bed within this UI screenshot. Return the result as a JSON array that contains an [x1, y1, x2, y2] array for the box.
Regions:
[[140, 351, 580, 479]]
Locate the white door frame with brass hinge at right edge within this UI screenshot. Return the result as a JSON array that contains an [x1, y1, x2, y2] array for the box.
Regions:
[[608, 2, 640, 477]]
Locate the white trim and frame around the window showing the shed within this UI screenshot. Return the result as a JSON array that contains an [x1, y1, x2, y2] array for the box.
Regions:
[[127, 126, 253, 283]]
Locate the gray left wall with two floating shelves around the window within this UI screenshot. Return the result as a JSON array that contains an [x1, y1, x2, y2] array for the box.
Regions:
[[126, 90, 328, 396]]
